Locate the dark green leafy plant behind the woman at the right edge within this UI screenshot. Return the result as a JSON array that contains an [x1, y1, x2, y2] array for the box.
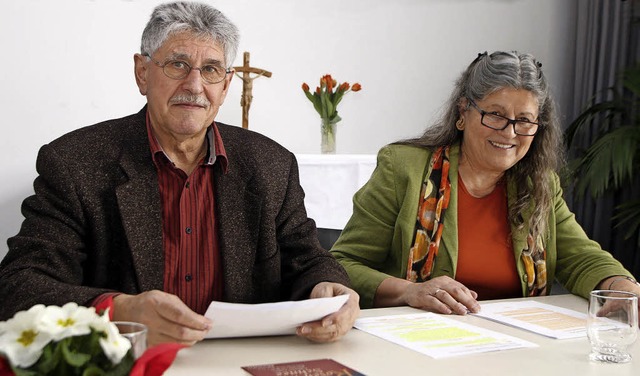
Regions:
[[565, 64, 640, 239]]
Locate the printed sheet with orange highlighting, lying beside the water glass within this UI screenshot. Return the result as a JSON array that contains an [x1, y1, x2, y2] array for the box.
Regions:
[[474, 300, 587, 339]]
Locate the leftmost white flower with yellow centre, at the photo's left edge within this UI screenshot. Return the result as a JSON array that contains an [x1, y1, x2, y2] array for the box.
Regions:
[[0, 304, 51, 368]]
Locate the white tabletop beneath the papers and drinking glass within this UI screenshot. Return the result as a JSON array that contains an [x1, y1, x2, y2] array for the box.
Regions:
[[165, 295, 640, 376]]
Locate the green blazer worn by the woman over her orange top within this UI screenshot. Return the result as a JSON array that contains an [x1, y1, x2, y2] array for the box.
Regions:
[[331, 145, 631, 308]]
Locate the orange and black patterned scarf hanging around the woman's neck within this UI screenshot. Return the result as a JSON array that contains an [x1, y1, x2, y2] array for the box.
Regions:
[[407, 146, 547, 296]]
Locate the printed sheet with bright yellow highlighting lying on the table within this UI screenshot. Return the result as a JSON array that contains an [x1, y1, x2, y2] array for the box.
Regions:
[[354, 312, 538, 359]]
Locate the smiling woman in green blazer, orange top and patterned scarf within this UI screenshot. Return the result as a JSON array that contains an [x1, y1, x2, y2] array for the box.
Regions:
[[331, 52, 640, 314]]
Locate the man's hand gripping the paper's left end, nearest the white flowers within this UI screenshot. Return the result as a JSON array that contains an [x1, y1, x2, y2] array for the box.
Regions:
[[113, 290, 213, 346]]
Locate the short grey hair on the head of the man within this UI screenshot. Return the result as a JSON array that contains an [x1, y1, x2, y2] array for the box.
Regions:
[[140, 1, 240, 68]]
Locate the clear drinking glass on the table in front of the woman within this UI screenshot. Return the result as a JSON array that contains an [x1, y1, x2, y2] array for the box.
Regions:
[[587, 290, 638, 363]]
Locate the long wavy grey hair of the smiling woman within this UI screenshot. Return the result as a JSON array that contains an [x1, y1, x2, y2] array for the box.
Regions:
[[400, 51, 564, 239]]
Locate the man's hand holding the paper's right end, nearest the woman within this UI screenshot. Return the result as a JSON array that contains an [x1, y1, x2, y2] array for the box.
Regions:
[[296, 282, 360, 342]]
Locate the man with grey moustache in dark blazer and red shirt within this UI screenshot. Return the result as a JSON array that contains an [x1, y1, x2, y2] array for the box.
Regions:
[[0, 2, 359, 344]]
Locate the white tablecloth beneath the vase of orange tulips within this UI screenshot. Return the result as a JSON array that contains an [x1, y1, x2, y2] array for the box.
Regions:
[[296, 154, 376, 230]]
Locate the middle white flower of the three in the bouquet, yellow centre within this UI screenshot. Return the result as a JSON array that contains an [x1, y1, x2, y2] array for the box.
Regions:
[[41, 302, 99, 341]]
